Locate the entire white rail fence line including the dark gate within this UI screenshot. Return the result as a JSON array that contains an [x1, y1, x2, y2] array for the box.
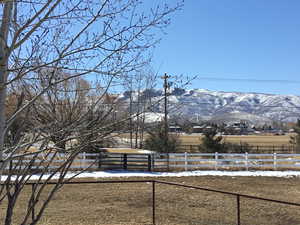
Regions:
[[6, 152, 300, 171]]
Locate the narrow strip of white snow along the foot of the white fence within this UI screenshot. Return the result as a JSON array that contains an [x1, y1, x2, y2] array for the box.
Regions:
[[1, 170, 300, 180]]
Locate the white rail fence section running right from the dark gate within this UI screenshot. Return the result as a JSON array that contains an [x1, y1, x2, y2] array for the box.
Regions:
[[153, 152, 300, 171]]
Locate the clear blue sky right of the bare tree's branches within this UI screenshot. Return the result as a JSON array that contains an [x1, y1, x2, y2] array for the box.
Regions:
[[153, 0, 300, 95]]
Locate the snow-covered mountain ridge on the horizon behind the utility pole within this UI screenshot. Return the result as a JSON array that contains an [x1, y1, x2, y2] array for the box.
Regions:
[[119, 88, 300, 124]]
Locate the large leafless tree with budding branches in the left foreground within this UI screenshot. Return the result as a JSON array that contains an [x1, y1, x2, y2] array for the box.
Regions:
[[0, 0, 182, 225]]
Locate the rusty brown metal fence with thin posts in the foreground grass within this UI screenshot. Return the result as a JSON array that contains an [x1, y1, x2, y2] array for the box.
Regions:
[[0, 180, 300, 225]]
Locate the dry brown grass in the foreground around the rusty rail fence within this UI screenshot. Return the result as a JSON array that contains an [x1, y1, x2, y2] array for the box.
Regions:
[[0, 176, 300, 225]]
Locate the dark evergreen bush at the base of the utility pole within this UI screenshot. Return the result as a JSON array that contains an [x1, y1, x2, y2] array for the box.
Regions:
[[144, 123, 180, 153]]
